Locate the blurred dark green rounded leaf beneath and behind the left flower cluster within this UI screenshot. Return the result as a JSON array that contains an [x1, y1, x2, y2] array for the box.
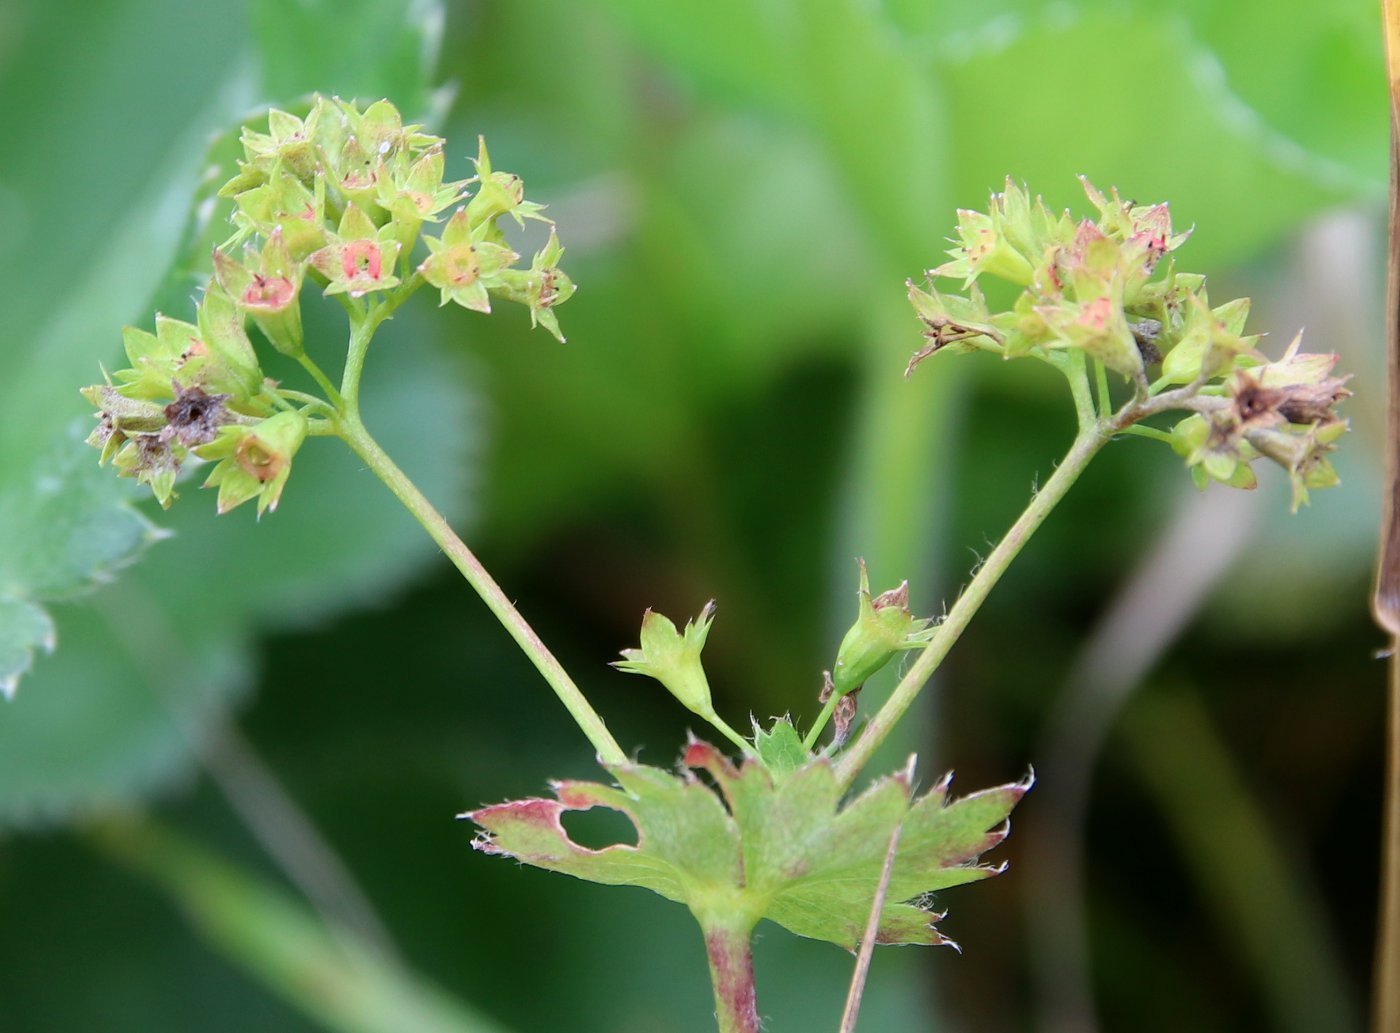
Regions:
[[0, 311, 470, 824]]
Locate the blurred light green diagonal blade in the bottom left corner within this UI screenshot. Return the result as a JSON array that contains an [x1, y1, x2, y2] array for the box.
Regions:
[[98, 823, 515, 1033]]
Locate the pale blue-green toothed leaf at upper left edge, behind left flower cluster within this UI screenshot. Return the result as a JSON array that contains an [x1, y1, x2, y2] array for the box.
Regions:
[[0, 3, 257, 697]]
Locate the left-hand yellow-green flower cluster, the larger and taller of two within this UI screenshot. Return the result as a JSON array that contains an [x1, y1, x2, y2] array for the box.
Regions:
[[83, 97, 574, 514]]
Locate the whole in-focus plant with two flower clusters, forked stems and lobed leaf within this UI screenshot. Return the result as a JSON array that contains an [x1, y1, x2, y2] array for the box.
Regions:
[[73, 98, 1348, 1033]]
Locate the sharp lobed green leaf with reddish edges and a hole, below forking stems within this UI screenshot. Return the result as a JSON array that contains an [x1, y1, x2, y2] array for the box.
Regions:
[[463, 742, 1030, 949]]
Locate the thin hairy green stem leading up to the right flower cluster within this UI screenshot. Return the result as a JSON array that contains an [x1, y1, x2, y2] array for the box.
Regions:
[[836, 422, 1116, 787]]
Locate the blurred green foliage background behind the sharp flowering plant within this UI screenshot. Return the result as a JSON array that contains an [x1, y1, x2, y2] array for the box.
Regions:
[[0, 0, 1387, 1033]]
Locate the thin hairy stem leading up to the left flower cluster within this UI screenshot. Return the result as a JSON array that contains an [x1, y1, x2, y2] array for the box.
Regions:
[[340, 405, 627, 764]]
